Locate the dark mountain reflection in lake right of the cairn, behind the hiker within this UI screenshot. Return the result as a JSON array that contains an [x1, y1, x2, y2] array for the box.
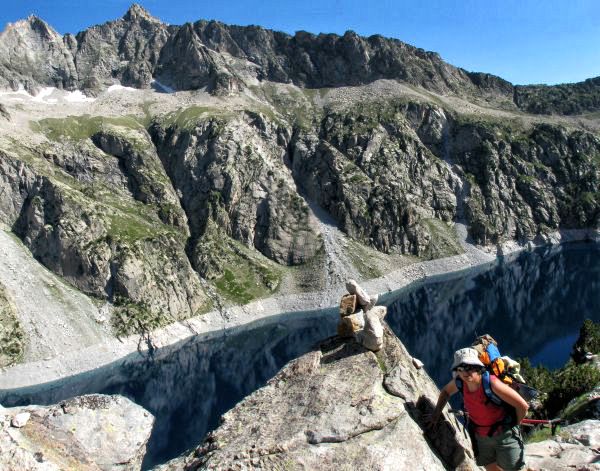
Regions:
[[387, 243, 600, 384]]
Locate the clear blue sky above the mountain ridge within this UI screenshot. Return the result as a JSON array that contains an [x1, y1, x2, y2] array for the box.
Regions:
[[0, 0, 600, 84]]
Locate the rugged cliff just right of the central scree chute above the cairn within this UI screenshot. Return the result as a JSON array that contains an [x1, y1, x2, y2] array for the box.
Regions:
[[292, 107, 456, 255]]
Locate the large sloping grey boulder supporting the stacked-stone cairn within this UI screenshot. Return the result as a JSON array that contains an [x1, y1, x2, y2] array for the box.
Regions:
[[161, 327, 476, 470]]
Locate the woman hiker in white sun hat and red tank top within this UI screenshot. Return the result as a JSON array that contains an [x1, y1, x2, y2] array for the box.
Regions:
[[429, 348, 529, 471]]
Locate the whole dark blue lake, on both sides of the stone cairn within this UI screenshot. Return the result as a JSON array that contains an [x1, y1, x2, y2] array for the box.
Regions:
[[0, 243, 600, 468]]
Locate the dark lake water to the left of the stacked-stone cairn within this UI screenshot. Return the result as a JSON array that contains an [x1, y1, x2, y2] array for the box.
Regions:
[[0, 310, 337, 468]]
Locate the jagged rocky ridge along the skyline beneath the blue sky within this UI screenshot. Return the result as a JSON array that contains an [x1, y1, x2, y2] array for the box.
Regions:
[[0, 4, 599, 114]]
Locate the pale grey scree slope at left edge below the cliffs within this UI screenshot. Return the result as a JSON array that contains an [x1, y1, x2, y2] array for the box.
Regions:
[[0, 230, 114, 362]]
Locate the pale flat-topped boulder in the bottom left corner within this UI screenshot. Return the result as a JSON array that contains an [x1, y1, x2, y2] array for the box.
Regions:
[[0, 394, 154, 471]]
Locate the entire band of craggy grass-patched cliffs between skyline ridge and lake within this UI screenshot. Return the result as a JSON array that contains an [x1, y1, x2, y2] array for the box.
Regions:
[[0, 87, 600, 342]]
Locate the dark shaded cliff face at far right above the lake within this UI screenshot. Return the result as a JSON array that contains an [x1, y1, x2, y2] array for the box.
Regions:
[[450, 123, 600, 244]]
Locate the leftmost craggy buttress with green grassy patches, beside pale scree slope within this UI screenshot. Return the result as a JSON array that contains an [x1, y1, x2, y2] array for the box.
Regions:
[[1, 128, 207, 334]]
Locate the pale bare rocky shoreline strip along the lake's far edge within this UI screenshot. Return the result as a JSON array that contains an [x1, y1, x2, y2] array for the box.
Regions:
[[0, 227, 600, 391]]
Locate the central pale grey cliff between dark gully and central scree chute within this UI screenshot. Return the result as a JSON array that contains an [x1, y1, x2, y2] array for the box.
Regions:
[[151, 113, 322, 278]]
